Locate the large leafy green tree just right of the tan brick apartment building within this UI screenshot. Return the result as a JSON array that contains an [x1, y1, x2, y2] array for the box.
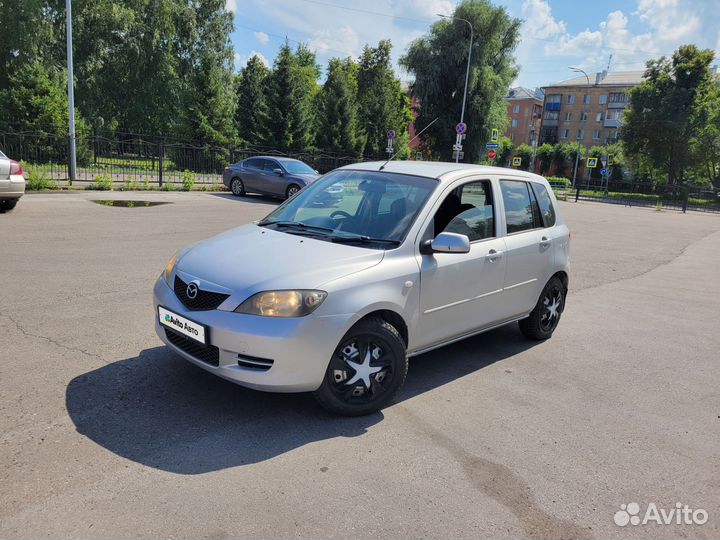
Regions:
[[622, 45, 713, 184]]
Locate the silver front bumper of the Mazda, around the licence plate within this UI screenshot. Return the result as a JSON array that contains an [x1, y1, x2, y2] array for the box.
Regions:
[[154, 276, 358, 392]]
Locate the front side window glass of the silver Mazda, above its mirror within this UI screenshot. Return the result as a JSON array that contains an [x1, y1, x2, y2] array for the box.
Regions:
[[426, 180, 495, 242]]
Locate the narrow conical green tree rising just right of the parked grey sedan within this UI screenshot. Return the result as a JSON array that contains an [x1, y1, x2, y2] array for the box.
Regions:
[[317, 58, 363, 155]]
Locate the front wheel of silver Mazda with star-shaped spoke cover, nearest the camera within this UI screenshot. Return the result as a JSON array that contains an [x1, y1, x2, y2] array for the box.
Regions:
[[313, 318, 408, 416]]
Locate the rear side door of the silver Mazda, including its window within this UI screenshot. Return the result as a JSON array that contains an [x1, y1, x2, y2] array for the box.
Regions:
[[500, 179, 554, 317]]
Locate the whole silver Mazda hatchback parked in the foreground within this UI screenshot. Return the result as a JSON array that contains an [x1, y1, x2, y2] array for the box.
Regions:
[[154, 162, 570, 415]]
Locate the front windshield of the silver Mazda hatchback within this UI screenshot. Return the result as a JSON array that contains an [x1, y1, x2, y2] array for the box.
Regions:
[[259, 170, 438, 248]]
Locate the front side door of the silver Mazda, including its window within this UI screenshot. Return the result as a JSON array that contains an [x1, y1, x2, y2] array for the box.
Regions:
[[414, 180, 506, 348]]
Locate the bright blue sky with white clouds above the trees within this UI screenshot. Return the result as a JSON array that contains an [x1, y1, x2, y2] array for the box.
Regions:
[[226, 0, 720, 88]]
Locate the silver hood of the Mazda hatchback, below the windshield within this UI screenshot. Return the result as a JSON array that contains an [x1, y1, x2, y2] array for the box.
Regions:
[[176, 224, 385, 296]]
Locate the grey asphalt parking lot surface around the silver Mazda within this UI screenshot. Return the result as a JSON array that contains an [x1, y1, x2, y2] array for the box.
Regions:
[[0, 192, 720, 538]]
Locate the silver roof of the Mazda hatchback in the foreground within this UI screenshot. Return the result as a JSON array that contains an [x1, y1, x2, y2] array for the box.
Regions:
[[338, 161, 547, 182]]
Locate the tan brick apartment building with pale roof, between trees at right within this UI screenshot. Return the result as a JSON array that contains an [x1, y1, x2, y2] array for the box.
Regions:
[[540, 71, 644, 148]]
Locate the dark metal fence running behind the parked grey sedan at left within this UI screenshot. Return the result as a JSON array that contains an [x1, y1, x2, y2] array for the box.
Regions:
[[0, 132, 381, 187]]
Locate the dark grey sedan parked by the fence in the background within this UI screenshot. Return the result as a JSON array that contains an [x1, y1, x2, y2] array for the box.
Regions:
[[223, 156, 320, 199]]
